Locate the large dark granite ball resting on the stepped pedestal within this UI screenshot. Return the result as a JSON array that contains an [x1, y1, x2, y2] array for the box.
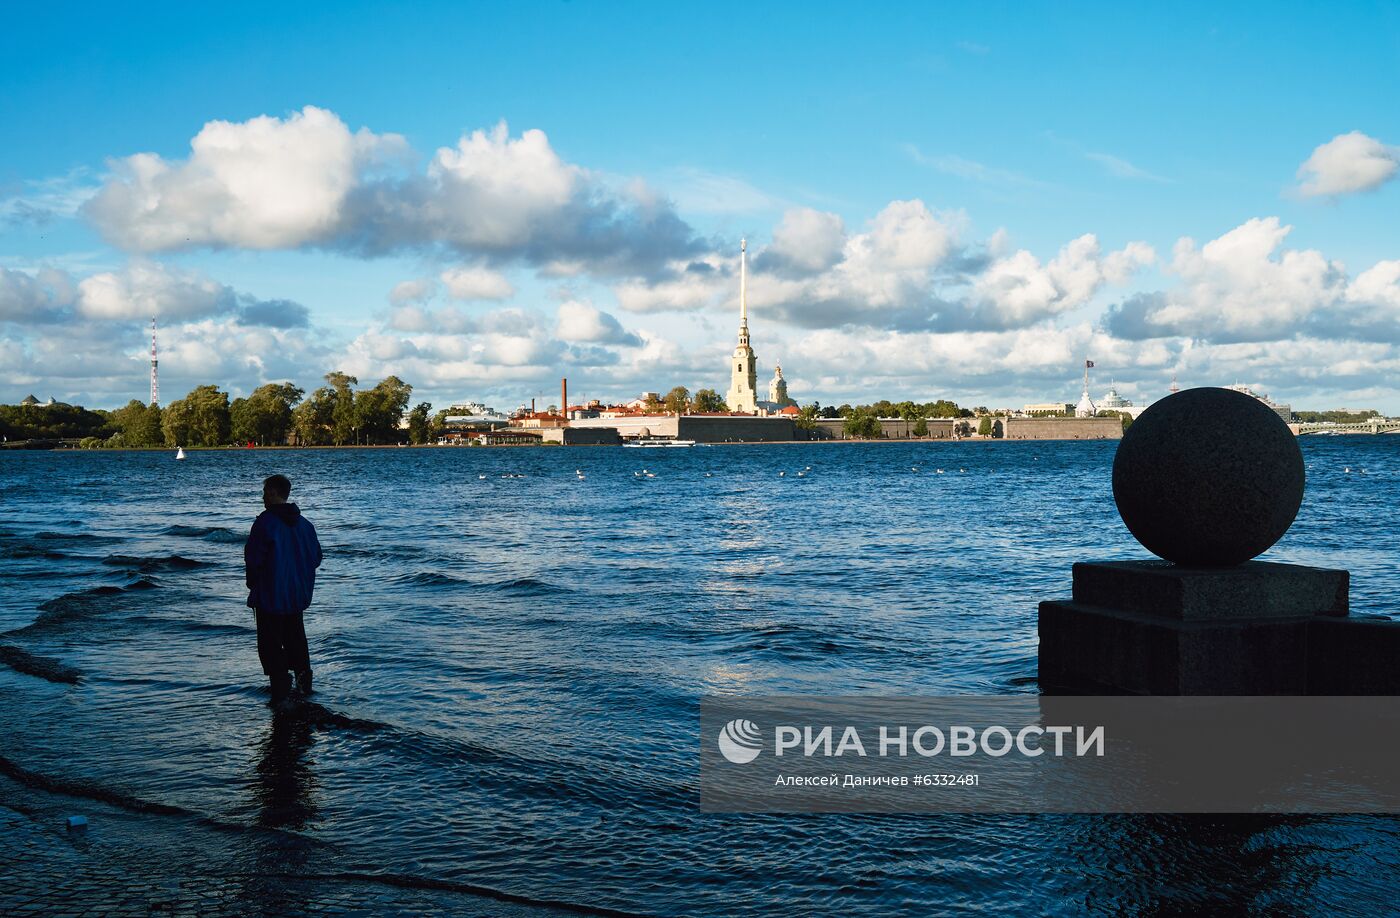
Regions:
[[1113, 389, 1306, 567]]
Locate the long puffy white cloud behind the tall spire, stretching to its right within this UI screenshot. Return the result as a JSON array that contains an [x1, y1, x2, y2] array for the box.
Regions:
[[615, 200, 1156, 332]]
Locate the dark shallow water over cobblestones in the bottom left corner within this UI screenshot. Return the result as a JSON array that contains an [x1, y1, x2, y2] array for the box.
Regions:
[[0, 775, 596, 918]]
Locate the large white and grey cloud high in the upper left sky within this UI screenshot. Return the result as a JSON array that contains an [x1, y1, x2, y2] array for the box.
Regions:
[[84, 105, 704, 276]]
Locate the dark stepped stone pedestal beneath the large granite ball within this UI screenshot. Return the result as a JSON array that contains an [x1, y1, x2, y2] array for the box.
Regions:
[[1039, 561, 1400, 695]]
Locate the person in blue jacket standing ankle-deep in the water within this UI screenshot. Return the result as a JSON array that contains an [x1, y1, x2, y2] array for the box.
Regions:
[[244, 474, 321, 704]]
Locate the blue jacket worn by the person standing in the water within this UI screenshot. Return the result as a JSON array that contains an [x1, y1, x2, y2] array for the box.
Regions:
[[244, 504, 321, 614]]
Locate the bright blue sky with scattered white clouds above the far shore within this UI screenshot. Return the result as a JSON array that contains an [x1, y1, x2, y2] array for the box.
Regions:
[[0, 3, 1400, 411]]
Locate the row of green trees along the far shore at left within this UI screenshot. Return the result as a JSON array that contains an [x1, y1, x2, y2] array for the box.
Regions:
[[0, 371, 431, 449]]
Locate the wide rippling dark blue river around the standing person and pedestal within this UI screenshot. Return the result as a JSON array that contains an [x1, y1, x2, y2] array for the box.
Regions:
[[0, 437, 1400, 915]]
